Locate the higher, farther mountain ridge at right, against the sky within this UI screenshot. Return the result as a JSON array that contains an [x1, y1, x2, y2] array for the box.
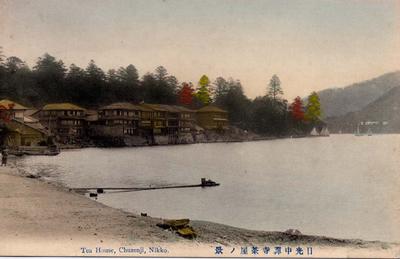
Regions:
[[318, 71, 400, 118]]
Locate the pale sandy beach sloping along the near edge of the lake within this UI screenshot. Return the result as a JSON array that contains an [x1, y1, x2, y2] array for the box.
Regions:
[[0, 167, 400, 257]]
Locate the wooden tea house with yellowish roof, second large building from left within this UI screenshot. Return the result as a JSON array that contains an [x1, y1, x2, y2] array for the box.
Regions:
[[34, 103, 86, 144]]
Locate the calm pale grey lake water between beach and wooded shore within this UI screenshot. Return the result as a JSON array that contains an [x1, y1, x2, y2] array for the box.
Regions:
[[15, 135, 400, 244]]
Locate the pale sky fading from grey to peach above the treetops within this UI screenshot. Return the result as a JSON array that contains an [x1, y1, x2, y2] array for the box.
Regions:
[[0, 0, 400, 99]]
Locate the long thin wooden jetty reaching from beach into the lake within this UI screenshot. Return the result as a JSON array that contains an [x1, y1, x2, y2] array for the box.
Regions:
[[69, 178, 220, 194]]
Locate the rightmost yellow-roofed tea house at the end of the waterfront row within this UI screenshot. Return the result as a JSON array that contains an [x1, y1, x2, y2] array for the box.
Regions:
[[196, 105, 229, 130]]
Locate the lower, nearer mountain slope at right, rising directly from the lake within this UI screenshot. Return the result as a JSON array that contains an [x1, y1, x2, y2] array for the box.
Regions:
[[326, 84, 400, 133]]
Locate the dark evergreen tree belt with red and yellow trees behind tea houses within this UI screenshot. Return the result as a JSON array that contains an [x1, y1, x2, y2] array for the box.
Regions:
[[0, 50, 321, 136]]
